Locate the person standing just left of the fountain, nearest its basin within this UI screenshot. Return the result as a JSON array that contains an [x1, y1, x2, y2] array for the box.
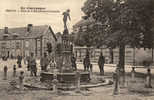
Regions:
[[40, 53, 49, 71]]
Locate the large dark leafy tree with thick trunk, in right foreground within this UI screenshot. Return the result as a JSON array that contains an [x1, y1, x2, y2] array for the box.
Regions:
[[76, 0, 154, 84]]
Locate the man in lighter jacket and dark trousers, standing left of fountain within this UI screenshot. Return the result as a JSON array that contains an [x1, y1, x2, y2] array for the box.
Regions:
[[29, 53, 37, 76]]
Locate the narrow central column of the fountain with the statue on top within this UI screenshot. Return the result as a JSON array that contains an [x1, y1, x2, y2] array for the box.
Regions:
[[61, 9, 73, 72]]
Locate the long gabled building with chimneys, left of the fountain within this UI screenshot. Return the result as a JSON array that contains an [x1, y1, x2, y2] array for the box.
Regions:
[[0, 24, 57, 57]]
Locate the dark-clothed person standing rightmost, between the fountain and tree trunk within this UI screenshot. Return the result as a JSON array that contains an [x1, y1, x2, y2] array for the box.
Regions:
[[98, 52, 105, 75]]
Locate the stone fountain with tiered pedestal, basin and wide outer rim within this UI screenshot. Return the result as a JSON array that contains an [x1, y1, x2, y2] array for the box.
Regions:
[[24, 9, 111, 92]]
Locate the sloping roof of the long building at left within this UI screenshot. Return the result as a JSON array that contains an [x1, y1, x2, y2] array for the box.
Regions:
[[0, 25, 57, 40]]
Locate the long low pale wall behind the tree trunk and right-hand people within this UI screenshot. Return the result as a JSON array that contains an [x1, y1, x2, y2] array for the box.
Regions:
[[74, 47, 152, 65]]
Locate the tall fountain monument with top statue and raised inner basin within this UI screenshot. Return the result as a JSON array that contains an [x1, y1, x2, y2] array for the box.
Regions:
[[40, 10, 90, 87]]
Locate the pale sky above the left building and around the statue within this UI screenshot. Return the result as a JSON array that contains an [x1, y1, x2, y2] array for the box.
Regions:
[[0, 0, 86, 32]]
